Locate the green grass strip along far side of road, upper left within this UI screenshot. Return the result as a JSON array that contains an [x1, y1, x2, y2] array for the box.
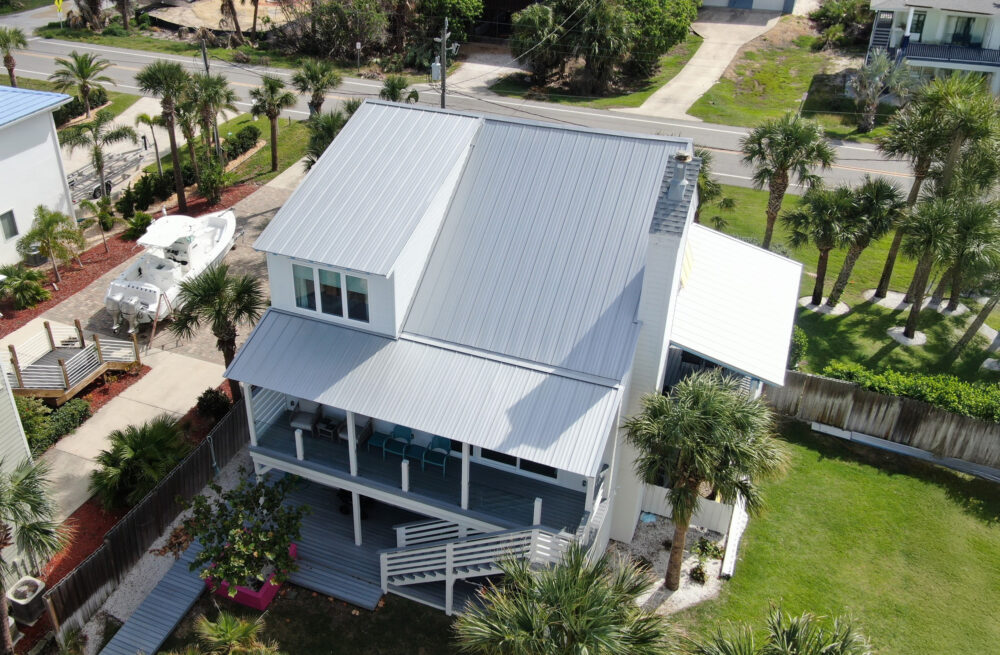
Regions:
[[35, 23, 434, 84]]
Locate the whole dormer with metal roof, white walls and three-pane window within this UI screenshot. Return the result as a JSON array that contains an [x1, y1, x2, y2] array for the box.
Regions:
[[254, 102, 482, 337]]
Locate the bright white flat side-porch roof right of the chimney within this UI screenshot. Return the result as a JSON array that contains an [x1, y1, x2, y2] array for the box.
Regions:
[[670, 225, 802, 385]]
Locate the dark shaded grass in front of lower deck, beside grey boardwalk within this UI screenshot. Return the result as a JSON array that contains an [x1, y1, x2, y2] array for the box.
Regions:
[[160, 585, 458, 655]]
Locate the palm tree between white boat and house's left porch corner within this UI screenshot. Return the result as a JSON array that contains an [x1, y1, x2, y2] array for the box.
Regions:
[[170, 264, 267, 401]]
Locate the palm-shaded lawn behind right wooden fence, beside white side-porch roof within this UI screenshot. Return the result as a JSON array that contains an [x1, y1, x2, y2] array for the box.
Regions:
[[702, 186, 1000, 381]]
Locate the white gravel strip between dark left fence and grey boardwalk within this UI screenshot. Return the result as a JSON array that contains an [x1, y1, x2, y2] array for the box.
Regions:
[[83, 448, 253, 655]]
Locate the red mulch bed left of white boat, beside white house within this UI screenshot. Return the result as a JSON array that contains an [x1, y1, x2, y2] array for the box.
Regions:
[[0, 236, 140, 337]]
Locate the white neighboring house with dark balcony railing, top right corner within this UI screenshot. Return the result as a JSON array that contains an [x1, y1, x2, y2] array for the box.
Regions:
[[868, 0, 1000, 94]]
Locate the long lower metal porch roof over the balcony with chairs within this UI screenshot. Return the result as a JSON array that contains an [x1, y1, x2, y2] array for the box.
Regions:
[[226, 308, 622, 476]]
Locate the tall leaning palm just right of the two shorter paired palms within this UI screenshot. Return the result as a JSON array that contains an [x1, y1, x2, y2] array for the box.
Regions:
[[875, 102, 947, 298]]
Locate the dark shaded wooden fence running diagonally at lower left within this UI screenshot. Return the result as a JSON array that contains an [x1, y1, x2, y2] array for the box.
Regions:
[[45, 400, 249, 636]]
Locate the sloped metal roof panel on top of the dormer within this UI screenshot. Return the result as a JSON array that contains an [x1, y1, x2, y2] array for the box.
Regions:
[[254, 102, 483, 275]]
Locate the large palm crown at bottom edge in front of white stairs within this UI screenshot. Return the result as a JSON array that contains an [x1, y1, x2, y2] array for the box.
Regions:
[[455, 544, 670, 655]]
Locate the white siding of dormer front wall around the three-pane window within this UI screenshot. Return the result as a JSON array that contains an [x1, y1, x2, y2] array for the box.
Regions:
[[267, 253, 396, 337]]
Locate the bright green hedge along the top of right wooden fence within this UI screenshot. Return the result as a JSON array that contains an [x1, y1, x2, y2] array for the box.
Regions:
[[823, 362, 1000, 423]]
